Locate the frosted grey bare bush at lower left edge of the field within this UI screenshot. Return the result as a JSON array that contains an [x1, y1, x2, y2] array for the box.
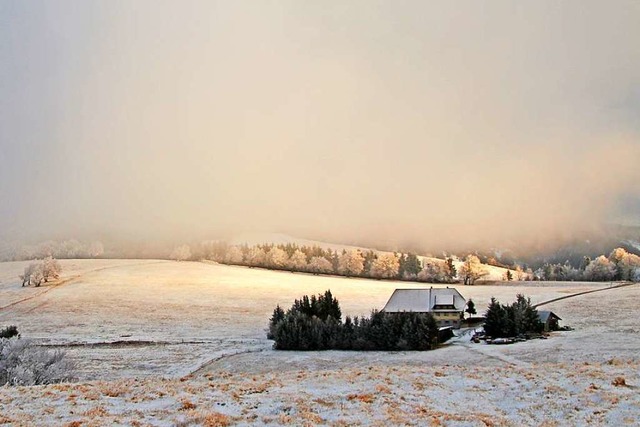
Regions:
[[0, 338, 74, 386]]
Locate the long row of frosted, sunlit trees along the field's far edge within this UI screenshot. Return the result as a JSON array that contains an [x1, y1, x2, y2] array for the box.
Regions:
[[171, 241, 640, 285]]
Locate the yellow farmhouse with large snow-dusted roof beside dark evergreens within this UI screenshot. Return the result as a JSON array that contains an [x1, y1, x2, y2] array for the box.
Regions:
[[382, 287, 467, 328]]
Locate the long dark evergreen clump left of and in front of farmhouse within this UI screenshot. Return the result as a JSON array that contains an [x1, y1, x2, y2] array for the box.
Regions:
[[267, 291, 438, 350]]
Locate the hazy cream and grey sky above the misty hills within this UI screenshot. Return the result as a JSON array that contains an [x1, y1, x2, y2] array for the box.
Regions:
[[0, 0, 640, 251]]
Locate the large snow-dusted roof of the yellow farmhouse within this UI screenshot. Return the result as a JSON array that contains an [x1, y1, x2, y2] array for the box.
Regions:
[[382, 287, 467, 313]]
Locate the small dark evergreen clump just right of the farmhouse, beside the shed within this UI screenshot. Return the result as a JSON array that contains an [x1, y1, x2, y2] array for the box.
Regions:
[[484, 294, 544, 338]]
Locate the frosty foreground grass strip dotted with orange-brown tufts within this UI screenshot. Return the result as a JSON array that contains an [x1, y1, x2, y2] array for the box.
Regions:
[[0, 360, 640, 426]]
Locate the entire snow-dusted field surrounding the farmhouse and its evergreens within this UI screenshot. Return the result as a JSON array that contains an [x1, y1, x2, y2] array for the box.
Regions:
[[0, 260, 640, 426]]
